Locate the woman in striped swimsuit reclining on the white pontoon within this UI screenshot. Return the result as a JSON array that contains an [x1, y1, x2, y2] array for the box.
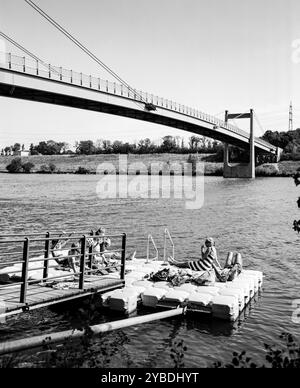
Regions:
[[168, 238, 242, 282]]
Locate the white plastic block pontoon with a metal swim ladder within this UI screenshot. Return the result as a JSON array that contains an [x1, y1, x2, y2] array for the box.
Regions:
[[101, 230, 263, 322]]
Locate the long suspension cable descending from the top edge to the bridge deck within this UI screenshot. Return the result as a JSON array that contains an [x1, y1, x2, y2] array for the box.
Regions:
[[24, 0, 147, 104]]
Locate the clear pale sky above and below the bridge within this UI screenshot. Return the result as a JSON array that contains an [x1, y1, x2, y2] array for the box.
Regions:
[[0, 0, 300, 148]]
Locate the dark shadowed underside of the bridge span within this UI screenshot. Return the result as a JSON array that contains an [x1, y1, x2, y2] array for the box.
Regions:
[[0, 82, 270, 154]]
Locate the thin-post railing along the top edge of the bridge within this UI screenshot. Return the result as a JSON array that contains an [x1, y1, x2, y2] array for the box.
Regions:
[[0, 53, 276, 147]]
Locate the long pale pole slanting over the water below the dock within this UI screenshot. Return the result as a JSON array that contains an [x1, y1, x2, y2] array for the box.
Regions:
[[0, 307, 185, 355]]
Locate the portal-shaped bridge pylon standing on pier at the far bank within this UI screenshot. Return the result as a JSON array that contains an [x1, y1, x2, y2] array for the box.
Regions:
[[223, 109, 255, 179]]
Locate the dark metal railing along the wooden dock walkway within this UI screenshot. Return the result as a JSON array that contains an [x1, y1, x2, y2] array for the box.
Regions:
[[0, 232, 126, 304]]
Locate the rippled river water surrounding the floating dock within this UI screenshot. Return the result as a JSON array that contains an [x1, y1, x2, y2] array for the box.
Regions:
[[0, 174, 300, 367]]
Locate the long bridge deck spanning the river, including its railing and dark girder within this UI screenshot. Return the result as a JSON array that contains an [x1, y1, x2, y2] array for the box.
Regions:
[[0, 53, 277, 154]]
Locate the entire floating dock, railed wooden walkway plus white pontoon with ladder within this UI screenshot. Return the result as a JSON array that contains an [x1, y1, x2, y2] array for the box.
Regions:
[[0, 230, 263, 322]]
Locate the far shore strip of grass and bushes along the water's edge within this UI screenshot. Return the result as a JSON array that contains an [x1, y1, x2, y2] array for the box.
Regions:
[[0, 153, 300, 177]]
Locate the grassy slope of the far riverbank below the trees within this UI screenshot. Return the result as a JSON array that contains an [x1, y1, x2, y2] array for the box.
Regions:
[[0, 154, 300, 176]]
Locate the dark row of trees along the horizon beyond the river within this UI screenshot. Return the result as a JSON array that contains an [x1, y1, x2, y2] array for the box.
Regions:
[[1, 128, 300, 160]]
